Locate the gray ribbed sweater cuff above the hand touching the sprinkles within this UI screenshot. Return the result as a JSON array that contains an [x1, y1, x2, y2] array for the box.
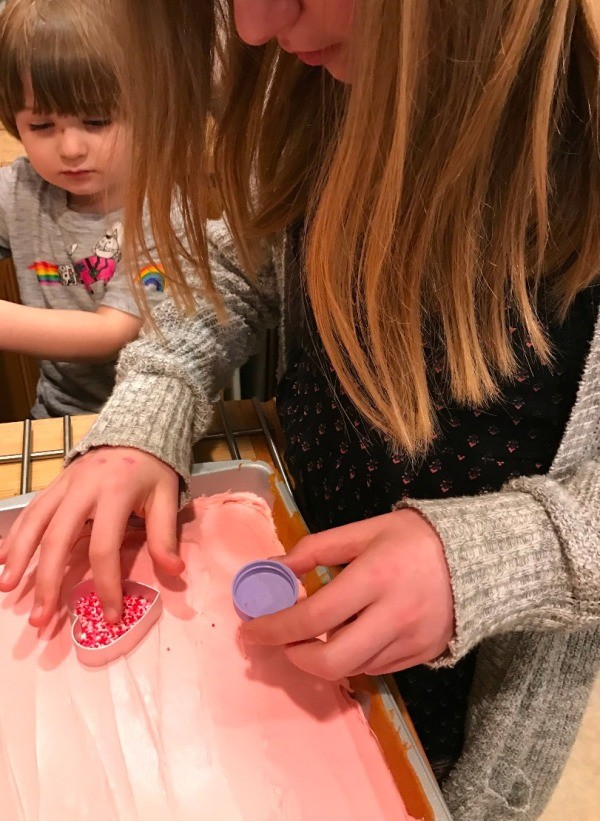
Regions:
[[66, 373, 199, 503]]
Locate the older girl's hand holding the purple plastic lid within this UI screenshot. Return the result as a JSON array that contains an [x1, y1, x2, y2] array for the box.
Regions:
[[241, 509, 454, 680]]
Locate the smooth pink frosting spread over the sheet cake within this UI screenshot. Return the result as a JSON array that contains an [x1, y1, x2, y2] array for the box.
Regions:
[[0, 494, 418, 821]]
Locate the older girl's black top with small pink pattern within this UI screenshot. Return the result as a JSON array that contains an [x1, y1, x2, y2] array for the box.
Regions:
[[277, 270, 600, 779]]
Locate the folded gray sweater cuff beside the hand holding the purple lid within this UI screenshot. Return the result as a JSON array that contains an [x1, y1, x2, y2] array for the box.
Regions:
[[397, 491, 573, 666]]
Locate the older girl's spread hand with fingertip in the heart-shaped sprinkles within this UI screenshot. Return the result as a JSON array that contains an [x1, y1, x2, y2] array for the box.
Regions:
[[0, 447, 184, 627]]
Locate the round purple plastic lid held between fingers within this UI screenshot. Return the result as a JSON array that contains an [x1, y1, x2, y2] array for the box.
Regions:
[[231, 559, 299, 621]]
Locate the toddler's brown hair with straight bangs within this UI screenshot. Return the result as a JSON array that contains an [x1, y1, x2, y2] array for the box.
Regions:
[[0, 0, 120, 139]]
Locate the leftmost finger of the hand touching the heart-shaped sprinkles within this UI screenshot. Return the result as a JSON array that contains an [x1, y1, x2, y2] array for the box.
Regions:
[[0, 484, 63, 593]]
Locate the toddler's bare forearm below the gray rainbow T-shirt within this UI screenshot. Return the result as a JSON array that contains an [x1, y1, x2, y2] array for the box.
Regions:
[[0, 300, 142, 362]]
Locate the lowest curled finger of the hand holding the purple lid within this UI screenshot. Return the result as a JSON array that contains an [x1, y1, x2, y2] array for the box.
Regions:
[[284, 605, 399, 681]]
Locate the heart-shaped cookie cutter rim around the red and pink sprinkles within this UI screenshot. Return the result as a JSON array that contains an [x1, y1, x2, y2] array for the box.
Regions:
[[67, 579, 162, 667]]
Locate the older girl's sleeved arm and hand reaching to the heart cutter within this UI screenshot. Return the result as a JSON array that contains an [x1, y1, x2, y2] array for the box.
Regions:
[[0, 216, 279, 627]]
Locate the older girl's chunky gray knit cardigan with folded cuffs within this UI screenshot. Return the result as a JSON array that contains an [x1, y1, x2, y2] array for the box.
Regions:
[[72, 223, 600, 821]]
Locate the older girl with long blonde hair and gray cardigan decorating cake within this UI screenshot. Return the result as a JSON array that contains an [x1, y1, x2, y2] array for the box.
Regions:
[[0, 0, 600, 821]]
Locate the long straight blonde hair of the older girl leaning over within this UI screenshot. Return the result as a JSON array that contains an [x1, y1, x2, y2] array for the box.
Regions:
[[115, 0, 600, 454]]
